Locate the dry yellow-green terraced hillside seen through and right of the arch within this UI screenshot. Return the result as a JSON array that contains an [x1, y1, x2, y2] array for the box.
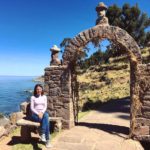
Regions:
[[77, 48, 150, 107]]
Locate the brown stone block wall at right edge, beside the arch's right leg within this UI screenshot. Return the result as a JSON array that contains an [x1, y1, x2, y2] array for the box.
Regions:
[[133, 64, 150, 141]]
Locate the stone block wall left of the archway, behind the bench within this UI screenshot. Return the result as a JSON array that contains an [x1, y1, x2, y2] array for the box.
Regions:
[[44, 66, 74, 128]]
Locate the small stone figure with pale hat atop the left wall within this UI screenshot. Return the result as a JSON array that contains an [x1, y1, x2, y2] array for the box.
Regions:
[[50, 45, 61, 66]]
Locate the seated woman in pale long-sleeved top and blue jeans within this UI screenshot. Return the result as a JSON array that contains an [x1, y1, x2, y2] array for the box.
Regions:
[[30, 84, 52, 148]]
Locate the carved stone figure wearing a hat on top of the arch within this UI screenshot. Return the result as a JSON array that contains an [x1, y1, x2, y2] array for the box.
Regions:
[[96, 2, 109, 25]]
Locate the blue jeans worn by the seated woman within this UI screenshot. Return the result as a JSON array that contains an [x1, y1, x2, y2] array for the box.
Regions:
[[31, 112, 50, 140]]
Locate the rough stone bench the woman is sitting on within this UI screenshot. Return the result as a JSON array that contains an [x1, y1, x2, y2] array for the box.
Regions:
[[16, 102, 62, 141]]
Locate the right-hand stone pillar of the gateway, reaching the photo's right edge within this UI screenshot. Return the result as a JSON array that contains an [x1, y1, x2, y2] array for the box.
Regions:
[[130, 64, 150, 141]]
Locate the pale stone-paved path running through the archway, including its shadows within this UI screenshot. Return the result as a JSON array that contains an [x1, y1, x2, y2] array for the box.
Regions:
[[51, 100, 143, 150]]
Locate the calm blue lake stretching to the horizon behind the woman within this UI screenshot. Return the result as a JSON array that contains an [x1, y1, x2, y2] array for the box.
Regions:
[[0, 76, 42, 115]]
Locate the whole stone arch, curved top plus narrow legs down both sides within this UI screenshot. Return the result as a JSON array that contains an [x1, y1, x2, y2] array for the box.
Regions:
[[62, 25, 142, 136]]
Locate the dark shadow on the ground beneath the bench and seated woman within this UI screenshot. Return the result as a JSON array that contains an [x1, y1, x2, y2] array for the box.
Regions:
[[7, 136, 43, 150]]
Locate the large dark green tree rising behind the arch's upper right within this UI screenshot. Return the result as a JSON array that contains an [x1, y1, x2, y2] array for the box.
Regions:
[[106, 3, 150, 48]]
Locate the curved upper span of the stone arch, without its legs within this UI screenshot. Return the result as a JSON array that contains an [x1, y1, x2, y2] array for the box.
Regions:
[[63, 25, 142, 65]]
